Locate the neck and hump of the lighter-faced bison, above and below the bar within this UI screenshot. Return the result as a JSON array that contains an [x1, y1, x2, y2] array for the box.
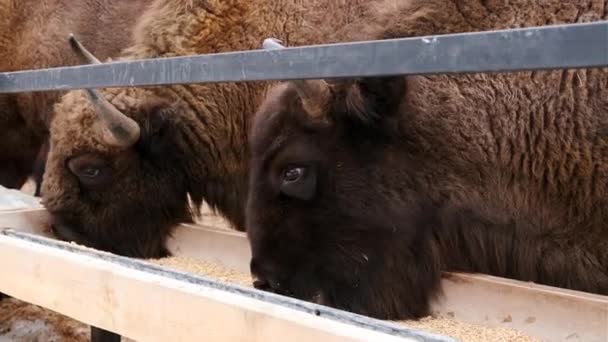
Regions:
[[125, 0, 368, 230]]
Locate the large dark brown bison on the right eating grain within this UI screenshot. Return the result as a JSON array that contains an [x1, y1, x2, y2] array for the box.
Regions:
[[246, 0, 608, 319]]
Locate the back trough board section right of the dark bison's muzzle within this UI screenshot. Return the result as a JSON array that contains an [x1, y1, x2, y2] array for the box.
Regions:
[[433, 273, 608, 342]]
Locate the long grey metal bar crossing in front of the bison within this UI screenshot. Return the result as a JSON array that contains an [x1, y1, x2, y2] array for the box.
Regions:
[[0, 21, 608, 93]]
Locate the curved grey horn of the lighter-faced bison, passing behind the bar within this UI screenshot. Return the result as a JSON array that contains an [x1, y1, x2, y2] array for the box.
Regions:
[[69, 34, 140, 147]]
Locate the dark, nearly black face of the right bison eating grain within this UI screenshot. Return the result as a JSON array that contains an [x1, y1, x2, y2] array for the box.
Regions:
[[246, 80, 440, 318]]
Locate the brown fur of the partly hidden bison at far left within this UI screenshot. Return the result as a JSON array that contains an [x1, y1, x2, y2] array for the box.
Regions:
[[0, 0, 151, 192]]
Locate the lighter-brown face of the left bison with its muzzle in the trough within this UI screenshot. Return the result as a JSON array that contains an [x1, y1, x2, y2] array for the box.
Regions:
[[43, 89, 197, 257]]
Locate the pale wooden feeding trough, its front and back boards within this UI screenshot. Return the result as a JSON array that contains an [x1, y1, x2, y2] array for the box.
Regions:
[[0, 200, 608, 342]]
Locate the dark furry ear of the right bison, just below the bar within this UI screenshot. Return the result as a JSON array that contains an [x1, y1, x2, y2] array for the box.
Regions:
[[343, 76, 405, 125]]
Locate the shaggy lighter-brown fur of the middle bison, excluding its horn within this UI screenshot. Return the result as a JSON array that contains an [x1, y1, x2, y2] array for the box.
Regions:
[[43, 0, 368, 257]]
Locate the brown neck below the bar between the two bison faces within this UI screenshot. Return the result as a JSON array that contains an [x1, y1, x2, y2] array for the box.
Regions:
[[173, 83, 265, 231]]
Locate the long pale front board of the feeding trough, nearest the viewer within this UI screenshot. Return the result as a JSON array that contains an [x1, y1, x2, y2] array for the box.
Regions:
[[0, 230, 450, 342]]
